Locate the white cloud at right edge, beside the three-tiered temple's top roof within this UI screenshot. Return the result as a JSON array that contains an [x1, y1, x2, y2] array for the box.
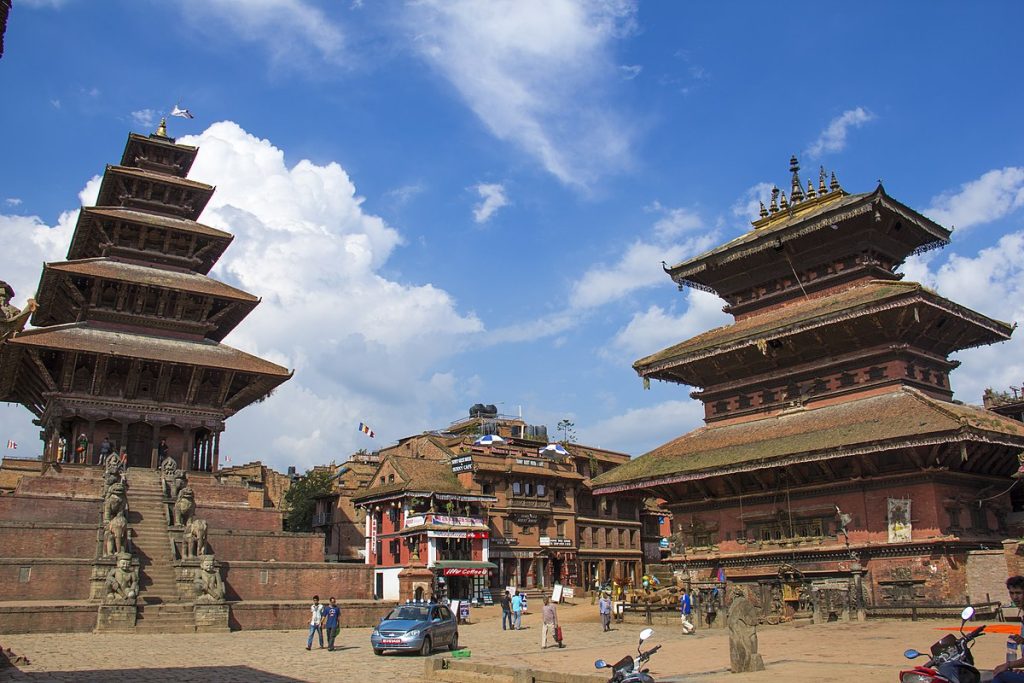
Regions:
[[924, 166, 1024, 229]]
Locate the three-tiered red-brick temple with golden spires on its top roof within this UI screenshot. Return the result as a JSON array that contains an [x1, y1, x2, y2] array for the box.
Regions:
[[594, 158, 1024, 620]]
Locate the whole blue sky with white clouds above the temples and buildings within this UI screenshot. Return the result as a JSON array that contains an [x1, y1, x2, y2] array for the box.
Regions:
[[0, 0, 1024, 468]]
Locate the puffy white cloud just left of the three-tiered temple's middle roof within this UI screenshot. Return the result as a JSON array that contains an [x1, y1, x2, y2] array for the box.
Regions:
[[611, 289, 732, 362]]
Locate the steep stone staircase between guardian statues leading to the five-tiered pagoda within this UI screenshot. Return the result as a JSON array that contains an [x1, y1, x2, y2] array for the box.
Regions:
[[128, 468, 196, 633]]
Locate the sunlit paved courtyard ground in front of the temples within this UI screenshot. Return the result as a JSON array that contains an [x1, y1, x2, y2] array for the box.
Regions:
[[0, 602, 1008, 683]]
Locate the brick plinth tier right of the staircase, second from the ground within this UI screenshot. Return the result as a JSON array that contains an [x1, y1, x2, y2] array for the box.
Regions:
[[217, 557, 374, 600]]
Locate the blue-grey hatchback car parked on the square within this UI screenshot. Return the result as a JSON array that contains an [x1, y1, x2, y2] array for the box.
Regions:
[[370, 602, 459, 655]]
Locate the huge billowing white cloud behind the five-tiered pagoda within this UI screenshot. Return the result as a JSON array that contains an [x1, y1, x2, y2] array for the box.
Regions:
[[0, 122, 483, 467]]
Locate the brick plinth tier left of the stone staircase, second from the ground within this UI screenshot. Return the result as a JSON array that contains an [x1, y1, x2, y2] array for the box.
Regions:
[[0, 559, 92, 601]]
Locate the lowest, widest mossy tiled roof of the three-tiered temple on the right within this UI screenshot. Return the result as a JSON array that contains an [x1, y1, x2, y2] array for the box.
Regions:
[[594, 387, 1024, 494]]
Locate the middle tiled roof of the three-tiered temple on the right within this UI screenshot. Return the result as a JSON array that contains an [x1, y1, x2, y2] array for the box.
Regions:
[[633, 280, 1013, 375]]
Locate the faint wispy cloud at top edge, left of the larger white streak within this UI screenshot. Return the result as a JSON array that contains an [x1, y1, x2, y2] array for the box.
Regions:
[[181, 0, 350, 69]]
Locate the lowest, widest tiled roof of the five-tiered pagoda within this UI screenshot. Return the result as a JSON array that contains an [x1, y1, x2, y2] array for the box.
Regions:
[[8, 323, 291, 378]]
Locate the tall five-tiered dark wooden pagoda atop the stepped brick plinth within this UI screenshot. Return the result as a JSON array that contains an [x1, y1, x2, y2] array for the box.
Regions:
[[0, 122, 291, 471]]
